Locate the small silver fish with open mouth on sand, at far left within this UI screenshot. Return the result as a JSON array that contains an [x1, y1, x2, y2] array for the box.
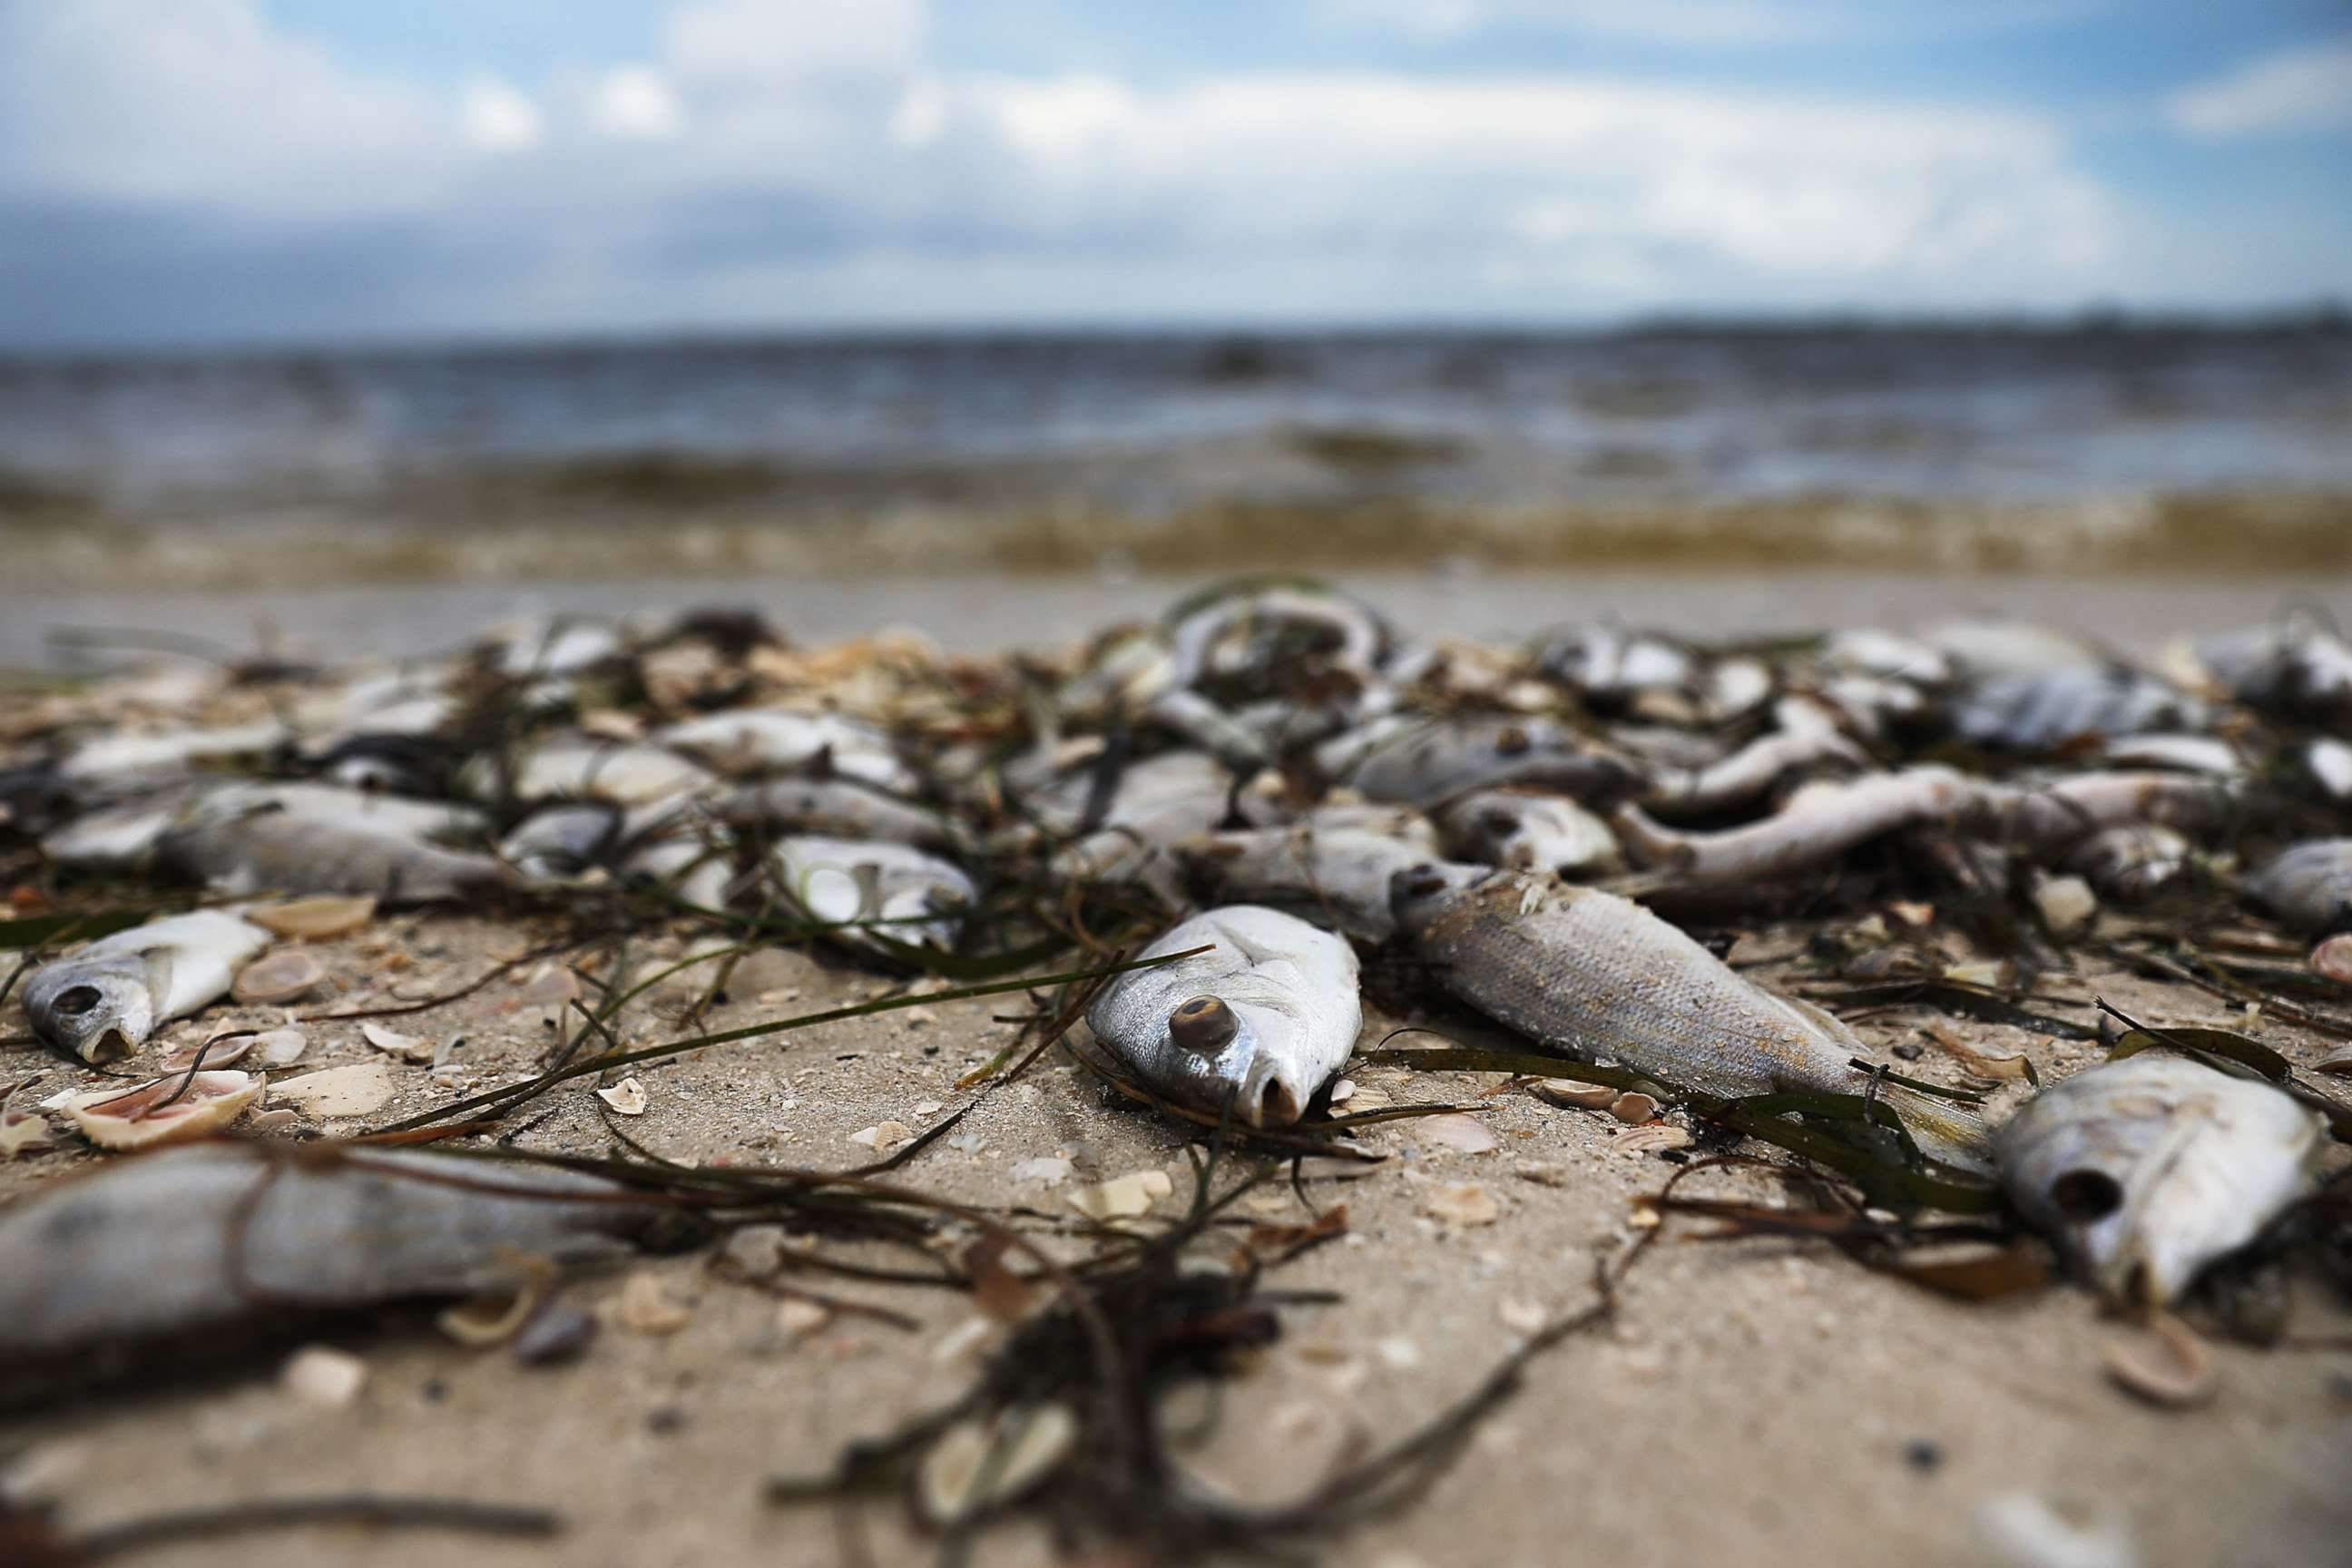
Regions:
[[24, 910, 270, 1063]]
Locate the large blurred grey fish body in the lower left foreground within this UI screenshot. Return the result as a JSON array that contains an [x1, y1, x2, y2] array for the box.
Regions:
[[0, 1145, 652, 1376]]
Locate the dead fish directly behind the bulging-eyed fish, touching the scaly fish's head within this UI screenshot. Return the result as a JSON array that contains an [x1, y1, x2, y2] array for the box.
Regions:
[[1176, 807, 1437, 943]]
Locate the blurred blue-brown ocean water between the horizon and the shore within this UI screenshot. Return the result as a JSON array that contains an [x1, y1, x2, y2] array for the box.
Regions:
[[0, 318, 2352, 580]]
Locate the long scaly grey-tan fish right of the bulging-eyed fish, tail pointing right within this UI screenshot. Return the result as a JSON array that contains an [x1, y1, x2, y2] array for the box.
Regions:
[[1395, 870, 1983, 1169]]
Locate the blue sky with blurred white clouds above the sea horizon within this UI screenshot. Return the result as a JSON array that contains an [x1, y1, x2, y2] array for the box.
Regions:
[[0, 0, 2352, 348]]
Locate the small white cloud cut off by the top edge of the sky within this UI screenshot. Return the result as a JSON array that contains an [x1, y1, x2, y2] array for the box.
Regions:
[[661, 0, 926, 83]]
